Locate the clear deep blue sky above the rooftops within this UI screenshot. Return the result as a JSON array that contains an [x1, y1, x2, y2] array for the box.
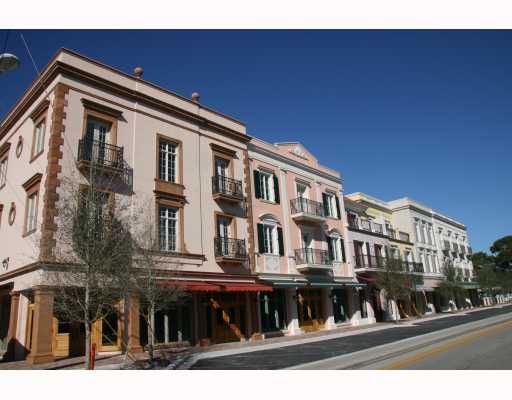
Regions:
[[0, 30, 512, 250]]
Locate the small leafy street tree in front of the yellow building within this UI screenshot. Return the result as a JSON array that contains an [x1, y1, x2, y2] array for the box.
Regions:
[[377, 257, 411, 323]]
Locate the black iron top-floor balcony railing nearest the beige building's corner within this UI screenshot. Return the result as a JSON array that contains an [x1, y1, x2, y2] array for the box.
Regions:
[[78, 138, 124, 169]]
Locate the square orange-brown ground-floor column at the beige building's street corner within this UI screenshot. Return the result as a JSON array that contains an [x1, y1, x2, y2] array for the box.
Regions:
[[27, 287, 54, 364]]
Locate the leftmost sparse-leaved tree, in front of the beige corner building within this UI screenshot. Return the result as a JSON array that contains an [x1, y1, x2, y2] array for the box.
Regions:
[[46, 168, 134, 369]]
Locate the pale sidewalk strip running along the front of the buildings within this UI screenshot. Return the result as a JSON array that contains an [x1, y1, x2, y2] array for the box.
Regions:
[[0, 304, 507, 370]]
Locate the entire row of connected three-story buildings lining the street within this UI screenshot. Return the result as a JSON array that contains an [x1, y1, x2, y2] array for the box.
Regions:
[[0, 49, 480, 363]]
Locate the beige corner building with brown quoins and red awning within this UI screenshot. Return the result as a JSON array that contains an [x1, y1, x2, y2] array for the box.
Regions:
[[0, 49, 264, 363]]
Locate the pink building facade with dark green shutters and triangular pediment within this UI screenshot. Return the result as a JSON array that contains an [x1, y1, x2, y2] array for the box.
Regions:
[[249, 138, 362, 335]]
